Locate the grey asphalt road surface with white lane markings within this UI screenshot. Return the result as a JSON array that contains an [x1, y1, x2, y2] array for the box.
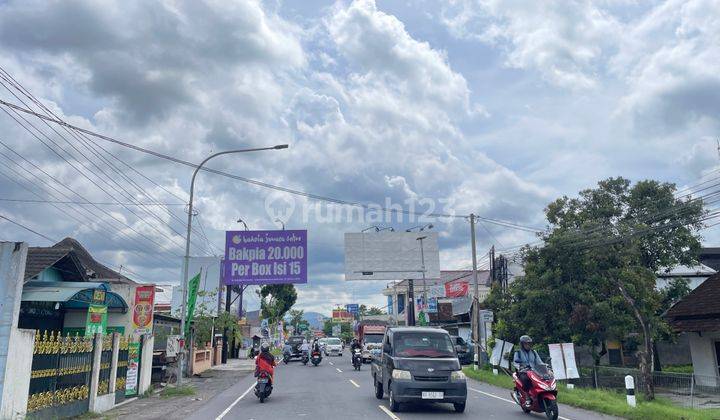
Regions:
[[184, 352, 610, 420]]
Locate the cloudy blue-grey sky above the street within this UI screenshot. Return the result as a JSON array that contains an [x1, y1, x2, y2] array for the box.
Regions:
[[0, 0, 720, 312]]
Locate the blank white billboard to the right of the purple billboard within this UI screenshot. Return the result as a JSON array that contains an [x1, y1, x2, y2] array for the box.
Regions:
[[345, 232, 440, 280]]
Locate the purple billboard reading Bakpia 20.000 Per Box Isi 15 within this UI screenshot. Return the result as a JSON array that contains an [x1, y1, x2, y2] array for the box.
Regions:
[[223, 230, 307, 285]]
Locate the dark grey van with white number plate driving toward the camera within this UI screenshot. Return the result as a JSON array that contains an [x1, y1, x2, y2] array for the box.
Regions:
[[370, 327, 467, 413]]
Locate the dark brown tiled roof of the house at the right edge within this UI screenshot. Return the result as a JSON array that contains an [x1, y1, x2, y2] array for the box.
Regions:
[[665, 274, 720, 331]]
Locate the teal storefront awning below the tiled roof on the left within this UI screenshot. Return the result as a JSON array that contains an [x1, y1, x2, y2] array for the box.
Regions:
[[21, 281, 128, 312]]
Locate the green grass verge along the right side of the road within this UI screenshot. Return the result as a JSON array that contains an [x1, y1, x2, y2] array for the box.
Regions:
[[463, 367, 720, 420]]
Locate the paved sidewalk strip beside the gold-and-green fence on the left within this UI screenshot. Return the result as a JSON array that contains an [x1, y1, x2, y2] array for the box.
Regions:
[[93, 359, 255, 419]]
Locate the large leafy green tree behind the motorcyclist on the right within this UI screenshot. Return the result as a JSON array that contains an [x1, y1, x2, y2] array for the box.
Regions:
[[487, 178, 705, 399]]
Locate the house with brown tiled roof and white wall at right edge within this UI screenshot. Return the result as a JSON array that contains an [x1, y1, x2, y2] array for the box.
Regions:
[[665, 274, 720, 386]]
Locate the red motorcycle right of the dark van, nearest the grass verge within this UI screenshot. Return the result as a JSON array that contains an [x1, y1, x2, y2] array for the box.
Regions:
[[512, 364, 558, 420]]
